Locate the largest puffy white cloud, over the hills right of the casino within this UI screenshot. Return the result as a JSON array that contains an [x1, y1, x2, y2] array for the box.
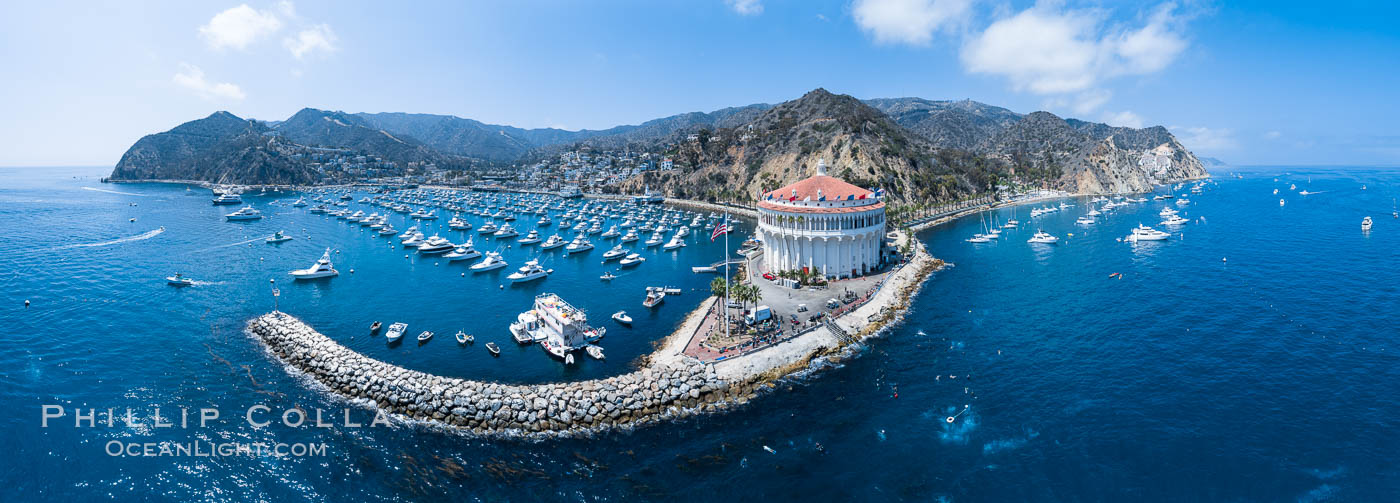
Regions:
[[959, 3, 1187, 113]]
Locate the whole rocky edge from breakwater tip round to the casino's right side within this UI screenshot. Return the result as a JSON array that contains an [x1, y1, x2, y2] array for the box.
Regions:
[[245, 234, 945, 439]]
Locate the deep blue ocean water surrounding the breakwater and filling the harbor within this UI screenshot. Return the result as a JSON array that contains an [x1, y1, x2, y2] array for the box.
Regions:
[[0, 168, 1400, 502]]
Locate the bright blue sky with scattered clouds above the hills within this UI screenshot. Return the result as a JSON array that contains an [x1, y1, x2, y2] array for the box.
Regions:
[[0, 0, 1400, 165]]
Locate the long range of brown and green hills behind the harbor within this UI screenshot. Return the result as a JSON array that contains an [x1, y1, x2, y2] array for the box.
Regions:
[[111, 88, 1207, 205]]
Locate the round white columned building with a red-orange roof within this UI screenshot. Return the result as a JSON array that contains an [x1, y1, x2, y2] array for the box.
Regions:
[[757, 160, 885, 277]]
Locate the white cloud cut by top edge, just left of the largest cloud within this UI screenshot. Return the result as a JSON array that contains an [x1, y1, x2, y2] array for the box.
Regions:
[[851, 0, 973, 46]]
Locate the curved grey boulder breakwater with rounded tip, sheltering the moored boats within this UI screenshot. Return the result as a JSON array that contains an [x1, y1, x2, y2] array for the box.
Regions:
[[248, 312, 753, 436]]
